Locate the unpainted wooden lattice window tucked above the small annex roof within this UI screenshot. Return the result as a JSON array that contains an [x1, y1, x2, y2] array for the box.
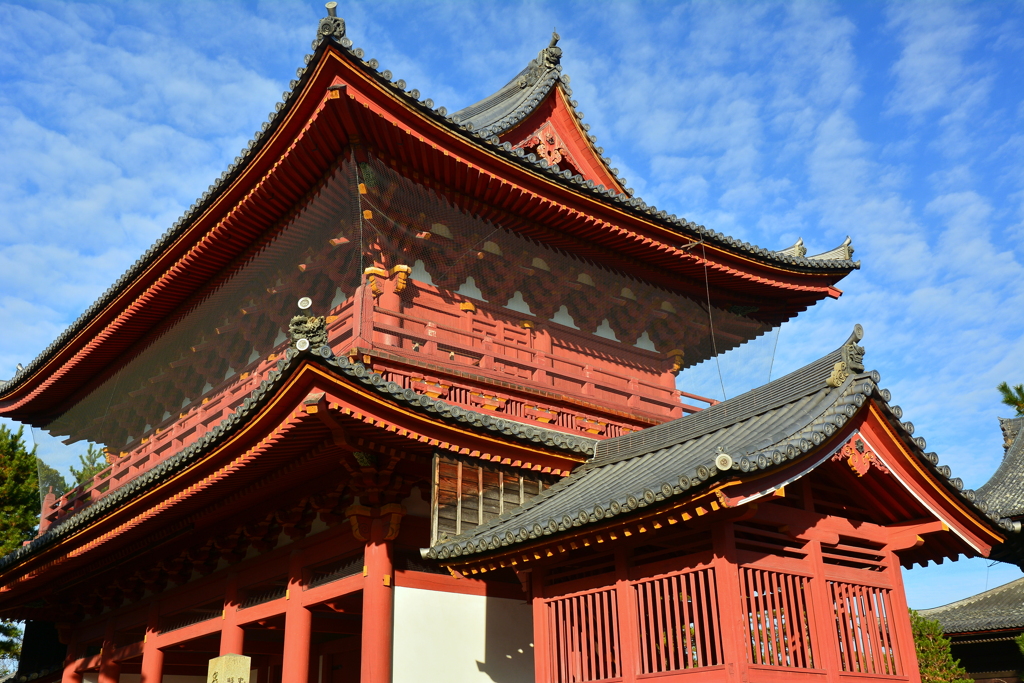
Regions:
[[431, 454, 556, 544]]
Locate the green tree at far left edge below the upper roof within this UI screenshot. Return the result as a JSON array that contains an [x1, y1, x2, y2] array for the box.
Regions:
[[0, 425, 39, 556]]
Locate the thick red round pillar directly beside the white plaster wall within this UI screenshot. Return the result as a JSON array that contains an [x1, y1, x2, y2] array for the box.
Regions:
[[359, 517, 394, 683]]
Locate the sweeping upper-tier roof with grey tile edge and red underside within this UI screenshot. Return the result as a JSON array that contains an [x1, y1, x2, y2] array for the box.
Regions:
[[0, 9, 859, 422]]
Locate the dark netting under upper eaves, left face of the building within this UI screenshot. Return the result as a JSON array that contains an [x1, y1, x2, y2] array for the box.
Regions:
[[46, 151, 360, 450]]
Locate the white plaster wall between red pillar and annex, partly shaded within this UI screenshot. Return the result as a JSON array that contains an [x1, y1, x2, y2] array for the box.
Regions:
[[392, 587, 534, 683]]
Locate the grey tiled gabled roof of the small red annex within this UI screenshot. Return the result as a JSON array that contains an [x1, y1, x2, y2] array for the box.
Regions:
[[421, 326, 1014, 563]]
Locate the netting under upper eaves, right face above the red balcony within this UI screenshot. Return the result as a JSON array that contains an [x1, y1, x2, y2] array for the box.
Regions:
[[358, 153, 769, 367]]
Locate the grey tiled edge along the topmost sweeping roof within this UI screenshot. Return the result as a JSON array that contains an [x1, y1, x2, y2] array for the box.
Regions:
[[0, 10, 860, 405]]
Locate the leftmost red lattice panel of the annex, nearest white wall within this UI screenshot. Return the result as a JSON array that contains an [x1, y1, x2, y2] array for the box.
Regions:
[[548, 589, 622, 683]]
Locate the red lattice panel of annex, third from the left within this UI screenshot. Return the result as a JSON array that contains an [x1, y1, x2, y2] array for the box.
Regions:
[[739, 567, 814, 669]]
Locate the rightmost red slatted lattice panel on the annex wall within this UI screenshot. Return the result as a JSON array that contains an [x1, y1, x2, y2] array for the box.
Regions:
[[827, 581, 903, 676]]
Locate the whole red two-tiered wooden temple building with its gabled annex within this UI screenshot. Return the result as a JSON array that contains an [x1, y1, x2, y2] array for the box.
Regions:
[[0, 3, 1012, 683]]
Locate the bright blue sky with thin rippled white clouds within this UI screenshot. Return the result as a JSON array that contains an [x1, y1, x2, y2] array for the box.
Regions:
[[0, 1, 1024, 607]]
